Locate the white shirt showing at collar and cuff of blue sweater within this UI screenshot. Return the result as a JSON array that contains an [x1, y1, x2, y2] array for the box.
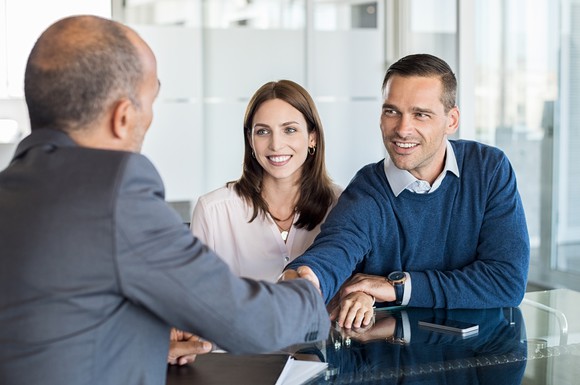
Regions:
[[385, 140, 459, 306]]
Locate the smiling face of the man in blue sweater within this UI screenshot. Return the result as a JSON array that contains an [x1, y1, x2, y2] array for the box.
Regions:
[[380, 75, 459, 183]]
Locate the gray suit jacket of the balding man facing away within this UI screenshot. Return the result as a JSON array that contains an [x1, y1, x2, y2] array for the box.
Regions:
[[0, 129, 329, 385]]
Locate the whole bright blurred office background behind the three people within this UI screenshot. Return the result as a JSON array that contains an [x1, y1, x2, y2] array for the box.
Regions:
[[0, 0, 580, 290]]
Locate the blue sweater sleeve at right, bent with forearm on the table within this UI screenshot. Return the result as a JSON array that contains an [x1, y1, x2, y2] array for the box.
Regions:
[[409, 155, 530, 308]]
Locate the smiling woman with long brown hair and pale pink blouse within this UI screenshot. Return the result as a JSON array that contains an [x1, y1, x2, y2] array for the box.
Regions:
[[191, 80, 341, 281]]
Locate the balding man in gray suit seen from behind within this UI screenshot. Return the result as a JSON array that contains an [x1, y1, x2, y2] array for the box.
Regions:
[[0, 16, 330, 385]]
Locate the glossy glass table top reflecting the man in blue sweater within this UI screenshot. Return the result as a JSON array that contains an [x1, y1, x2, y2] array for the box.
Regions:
[[297, 289, 580, 385]]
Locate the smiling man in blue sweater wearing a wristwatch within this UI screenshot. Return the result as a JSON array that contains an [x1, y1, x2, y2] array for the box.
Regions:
[[281, 54, 530, 327]]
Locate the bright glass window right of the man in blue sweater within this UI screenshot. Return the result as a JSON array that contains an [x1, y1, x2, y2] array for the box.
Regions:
[[475, 0, 580, 288]]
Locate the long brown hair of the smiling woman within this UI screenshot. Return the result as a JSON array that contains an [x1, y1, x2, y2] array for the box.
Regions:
[[228, 80, 334, 230]]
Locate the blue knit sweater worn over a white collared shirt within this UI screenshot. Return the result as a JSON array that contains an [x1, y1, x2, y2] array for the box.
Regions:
[[287, 140, 530, 308]]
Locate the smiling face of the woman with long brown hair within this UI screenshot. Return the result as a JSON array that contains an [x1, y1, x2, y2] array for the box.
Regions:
[[250, 99, 316, 182]]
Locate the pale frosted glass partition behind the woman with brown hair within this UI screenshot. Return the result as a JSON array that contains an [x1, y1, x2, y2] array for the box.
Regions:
[[113, 0, 385, 200]]
